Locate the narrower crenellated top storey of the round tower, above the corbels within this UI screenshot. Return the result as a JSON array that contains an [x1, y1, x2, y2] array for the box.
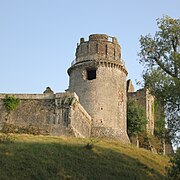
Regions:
[[75, 34, 122, 64]]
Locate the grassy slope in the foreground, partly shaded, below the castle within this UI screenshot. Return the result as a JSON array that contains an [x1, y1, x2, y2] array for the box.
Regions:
[[0, 135, 168, 180]]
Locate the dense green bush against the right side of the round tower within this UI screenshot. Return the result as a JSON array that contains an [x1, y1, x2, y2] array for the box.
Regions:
[[127, 100, 147, 136]]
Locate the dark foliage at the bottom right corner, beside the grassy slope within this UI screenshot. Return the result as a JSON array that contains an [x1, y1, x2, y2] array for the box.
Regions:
[[167, 148, 180, 180]]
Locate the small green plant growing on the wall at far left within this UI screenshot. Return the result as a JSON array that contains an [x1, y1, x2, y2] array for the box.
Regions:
[[4, 96, 20, 113]]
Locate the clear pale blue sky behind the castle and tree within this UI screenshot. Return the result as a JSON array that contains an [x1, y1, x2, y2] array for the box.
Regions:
[[0, 0, 180, 93]]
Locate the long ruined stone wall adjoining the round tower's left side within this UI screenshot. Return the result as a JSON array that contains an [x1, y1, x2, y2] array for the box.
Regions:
[[0, 93, 91, 137]]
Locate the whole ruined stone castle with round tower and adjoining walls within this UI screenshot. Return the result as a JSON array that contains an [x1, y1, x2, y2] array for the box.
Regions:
[[0, 34, 154, 143]]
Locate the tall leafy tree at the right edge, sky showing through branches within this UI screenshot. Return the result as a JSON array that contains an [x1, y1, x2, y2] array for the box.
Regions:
[[138, 16, 180, 143]]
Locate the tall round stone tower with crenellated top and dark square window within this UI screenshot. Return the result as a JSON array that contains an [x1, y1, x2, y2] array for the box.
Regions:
[[68, 34, 129, 143]]
